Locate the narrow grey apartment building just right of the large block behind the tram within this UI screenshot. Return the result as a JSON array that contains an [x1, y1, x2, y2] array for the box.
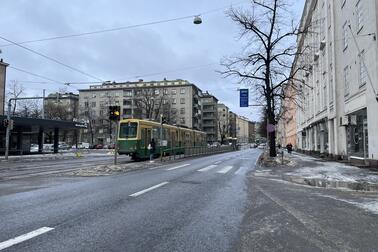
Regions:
[[200, 92, 218, 143]]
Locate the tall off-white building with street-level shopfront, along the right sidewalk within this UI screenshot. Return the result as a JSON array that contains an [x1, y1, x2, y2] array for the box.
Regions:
[[286, 0, 378, 161]]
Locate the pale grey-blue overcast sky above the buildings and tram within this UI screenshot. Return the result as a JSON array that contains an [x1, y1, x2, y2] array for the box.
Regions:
[[0, 0, 304, 120]]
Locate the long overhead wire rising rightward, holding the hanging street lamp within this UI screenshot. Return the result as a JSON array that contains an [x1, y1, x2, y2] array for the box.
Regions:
[[0, 1, 247, 47]]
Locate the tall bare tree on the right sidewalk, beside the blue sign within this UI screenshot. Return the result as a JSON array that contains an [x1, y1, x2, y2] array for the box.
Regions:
[[221, 0, 307, 156]]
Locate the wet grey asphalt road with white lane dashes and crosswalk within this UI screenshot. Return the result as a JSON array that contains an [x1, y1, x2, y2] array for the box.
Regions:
[[0, 149, 378, 251]]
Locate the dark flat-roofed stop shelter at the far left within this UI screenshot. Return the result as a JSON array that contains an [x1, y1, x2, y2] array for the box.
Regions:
[[0, 116, 87, 155]]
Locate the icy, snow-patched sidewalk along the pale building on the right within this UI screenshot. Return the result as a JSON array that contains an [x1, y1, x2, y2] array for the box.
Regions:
[[255, 152, 378, 191]]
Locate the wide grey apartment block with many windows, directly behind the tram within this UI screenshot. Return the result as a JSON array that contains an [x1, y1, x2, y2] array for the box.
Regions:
[[79, 79, 202, 146]]
